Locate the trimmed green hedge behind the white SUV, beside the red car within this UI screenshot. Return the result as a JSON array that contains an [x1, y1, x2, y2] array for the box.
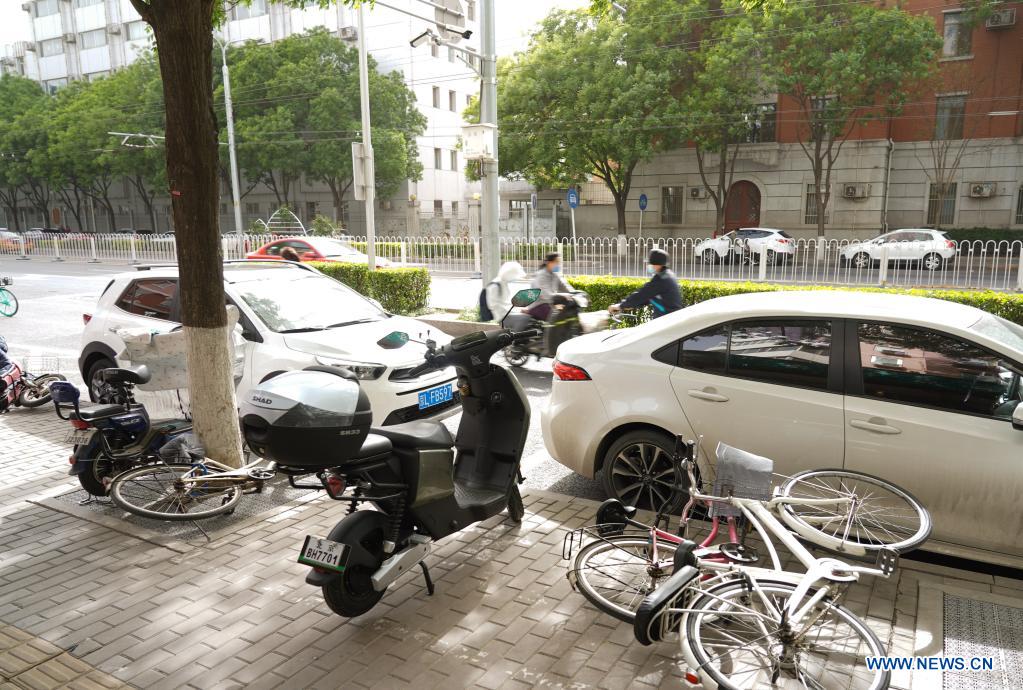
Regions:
[[310, 261, 430, 315]]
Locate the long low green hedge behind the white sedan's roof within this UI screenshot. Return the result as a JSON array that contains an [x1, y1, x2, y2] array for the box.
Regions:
[[568, 275, 1023, 326]]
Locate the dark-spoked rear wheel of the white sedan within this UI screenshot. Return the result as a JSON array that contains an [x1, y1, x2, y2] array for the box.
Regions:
[[601, 430, 688, 513]]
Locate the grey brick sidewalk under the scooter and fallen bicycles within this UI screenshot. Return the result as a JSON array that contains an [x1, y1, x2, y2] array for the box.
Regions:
[[0, 409, 1020, 690]]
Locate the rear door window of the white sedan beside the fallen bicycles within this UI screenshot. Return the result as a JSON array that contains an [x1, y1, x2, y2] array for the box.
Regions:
[[727, 319, 831, 389]]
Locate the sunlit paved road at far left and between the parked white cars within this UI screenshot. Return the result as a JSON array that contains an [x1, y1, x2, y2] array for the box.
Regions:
[[0, 258, 604, 499]]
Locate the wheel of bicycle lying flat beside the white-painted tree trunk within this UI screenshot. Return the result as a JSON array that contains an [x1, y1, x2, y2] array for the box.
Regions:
[[110, 465, 241, 520]]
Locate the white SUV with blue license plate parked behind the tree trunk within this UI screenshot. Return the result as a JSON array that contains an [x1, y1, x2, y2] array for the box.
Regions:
[[79, 261, 458, 426]]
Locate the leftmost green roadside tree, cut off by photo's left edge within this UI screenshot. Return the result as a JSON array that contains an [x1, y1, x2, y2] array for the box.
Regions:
[[0, 75, 48, 230]]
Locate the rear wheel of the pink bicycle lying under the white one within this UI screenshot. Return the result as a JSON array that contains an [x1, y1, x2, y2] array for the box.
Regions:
[[572, 535, 675, 622]]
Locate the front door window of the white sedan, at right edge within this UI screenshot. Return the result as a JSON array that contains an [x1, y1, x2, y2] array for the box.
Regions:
[[857, 324, 1020, 420]]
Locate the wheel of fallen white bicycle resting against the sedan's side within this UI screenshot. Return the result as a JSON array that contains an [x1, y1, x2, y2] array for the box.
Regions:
[[782, 470, 931, 553]]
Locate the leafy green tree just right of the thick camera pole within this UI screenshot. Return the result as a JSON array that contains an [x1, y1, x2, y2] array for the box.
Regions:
[[497, 11, 677, 232]]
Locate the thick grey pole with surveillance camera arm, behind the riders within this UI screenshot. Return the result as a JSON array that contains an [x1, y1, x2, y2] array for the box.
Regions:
[[480, 0, 500, 285]]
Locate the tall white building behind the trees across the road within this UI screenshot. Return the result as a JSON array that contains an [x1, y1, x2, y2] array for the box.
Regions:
[[0, 0, 479, 234]]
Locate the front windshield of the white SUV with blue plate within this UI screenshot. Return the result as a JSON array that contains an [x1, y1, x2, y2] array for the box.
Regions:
[[234, 271, 388, 333]]
